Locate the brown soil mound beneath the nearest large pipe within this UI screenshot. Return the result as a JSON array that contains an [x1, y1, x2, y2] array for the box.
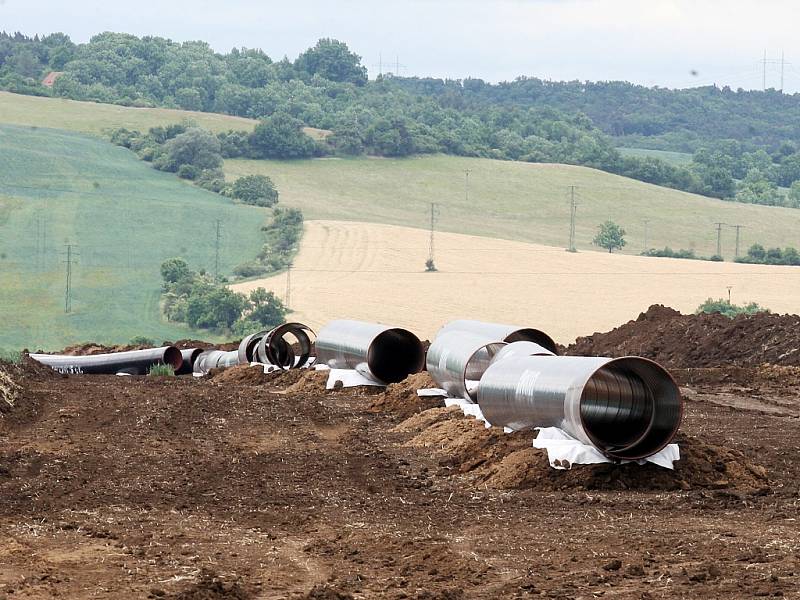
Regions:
[[395, 407, 768, 490]]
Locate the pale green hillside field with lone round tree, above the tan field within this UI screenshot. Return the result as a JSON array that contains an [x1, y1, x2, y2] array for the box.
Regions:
[[225, 155, 800, 258]]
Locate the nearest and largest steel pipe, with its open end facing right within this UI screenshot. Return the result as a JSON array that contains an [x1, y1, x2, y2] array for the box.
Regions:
[[478, 356, 683, 459]]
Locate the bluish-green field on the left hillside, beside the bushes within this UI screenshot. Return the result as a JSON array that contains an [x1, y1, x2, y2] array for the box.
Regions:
[[0, 125, 267, 350]]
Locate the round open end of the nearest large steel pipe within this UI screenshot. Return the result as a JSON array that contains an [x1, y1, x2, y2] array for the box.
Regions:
[[580, 356, 683, 460]]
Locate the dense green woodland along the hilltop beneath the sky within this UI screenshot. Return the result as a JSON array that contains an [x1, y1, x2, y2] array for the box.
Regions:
[[0, 32, 800, 206]]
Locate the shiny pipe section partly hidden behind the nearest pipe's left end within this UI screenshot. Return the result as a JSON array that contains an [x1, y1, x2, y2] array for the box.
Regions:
[[425, 329, 507, 402]]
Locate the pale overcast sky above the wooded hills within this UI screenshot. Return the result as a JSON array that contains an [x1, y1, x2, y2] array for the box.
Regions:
[[0, 0, 800, 91]]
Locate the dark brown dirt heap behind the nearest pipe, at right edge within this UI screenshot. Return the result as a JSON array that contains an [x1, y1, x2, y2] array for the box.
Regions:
[[566, 305, 800, 368]]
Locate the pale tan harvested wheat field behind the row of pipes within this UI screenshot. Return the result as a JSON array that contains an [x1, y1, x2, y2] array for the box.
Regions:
[[232, 221, 800, 343]]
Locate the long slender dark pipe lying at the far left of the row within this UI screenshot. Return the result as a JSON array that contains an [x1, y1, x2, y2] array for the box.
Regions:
[[30, 346, 183, 375]]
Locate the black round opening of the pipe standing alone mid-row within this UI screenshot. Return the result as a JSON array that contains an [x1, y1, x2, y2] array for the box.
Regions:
[[367, 329, 425, 383]]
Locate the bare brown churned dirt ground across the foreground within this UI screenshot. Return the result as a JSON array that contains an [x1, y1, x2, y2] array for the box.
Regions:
[[0, 358, 800, 599]]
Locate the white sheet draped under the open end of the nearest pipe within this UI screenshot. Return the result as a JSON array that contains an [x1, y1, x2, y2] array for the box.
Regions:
[[533, 427, 681, 469]]
